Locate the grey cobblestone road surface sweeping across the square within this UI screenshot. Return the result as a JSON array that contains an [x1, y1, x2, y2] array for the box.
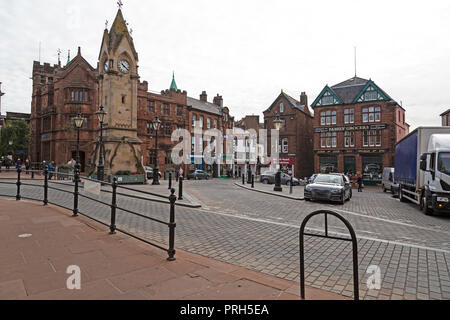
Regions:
[[0, 180, 450, 299]]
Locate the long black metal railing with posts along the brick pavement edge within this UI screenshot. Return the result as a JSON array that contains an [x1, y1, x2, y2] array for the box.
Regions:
[[0, 166, 182, 261]]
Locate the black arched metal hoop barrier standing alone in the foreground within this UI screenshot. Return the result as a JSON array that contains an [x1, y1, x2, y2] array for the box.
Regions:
[[299, 210, 359, 300]]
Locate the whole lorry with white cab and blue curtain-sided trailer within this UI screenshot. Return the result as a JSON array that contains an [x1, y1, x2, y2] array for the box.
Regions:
[[394, 127, 450, 215]]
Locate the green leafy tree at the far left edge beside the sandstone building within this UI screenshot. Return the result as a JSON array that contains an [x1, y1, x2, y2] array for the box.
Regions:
[[0, 120, 30, 159]]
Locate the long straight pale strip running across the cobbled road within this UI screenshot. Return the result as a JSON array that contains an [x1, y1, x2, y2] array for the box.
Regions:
[[194, 209, 450, 253]]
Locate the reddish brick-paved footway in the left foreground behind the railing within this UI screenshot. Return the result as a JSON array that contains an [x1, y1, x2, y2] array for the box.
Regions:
[[0, 199, 344, 300]]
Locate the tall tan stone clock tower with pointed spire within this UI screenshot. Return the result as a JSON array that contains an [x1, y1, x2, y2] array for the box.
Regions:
[[94, 9, 144, 175]]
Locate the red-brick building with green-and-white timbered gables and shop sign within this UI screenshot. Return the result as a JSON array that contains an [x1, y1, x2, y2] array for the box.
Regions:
[[311, 77, 409, 180]]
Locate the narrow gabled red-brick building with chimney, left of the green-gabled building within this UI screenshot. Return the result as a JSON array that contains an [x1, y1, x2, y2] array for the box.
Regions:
[[263, 91, 314, 178]]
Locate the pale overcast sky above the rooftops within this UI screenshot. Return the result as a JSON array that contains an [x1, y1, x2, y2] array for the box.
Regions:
[[0, 0, 450, 129]]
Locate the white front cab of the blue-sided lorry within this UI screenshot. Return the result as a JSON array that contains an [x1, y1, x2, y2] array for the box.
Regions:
[[420, 134, 450, 213]]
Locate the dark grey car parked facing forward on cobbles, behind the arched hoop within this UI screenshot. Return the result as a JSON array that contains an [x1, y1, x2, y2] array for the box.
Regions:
[[304, 173, 352, 204]]
